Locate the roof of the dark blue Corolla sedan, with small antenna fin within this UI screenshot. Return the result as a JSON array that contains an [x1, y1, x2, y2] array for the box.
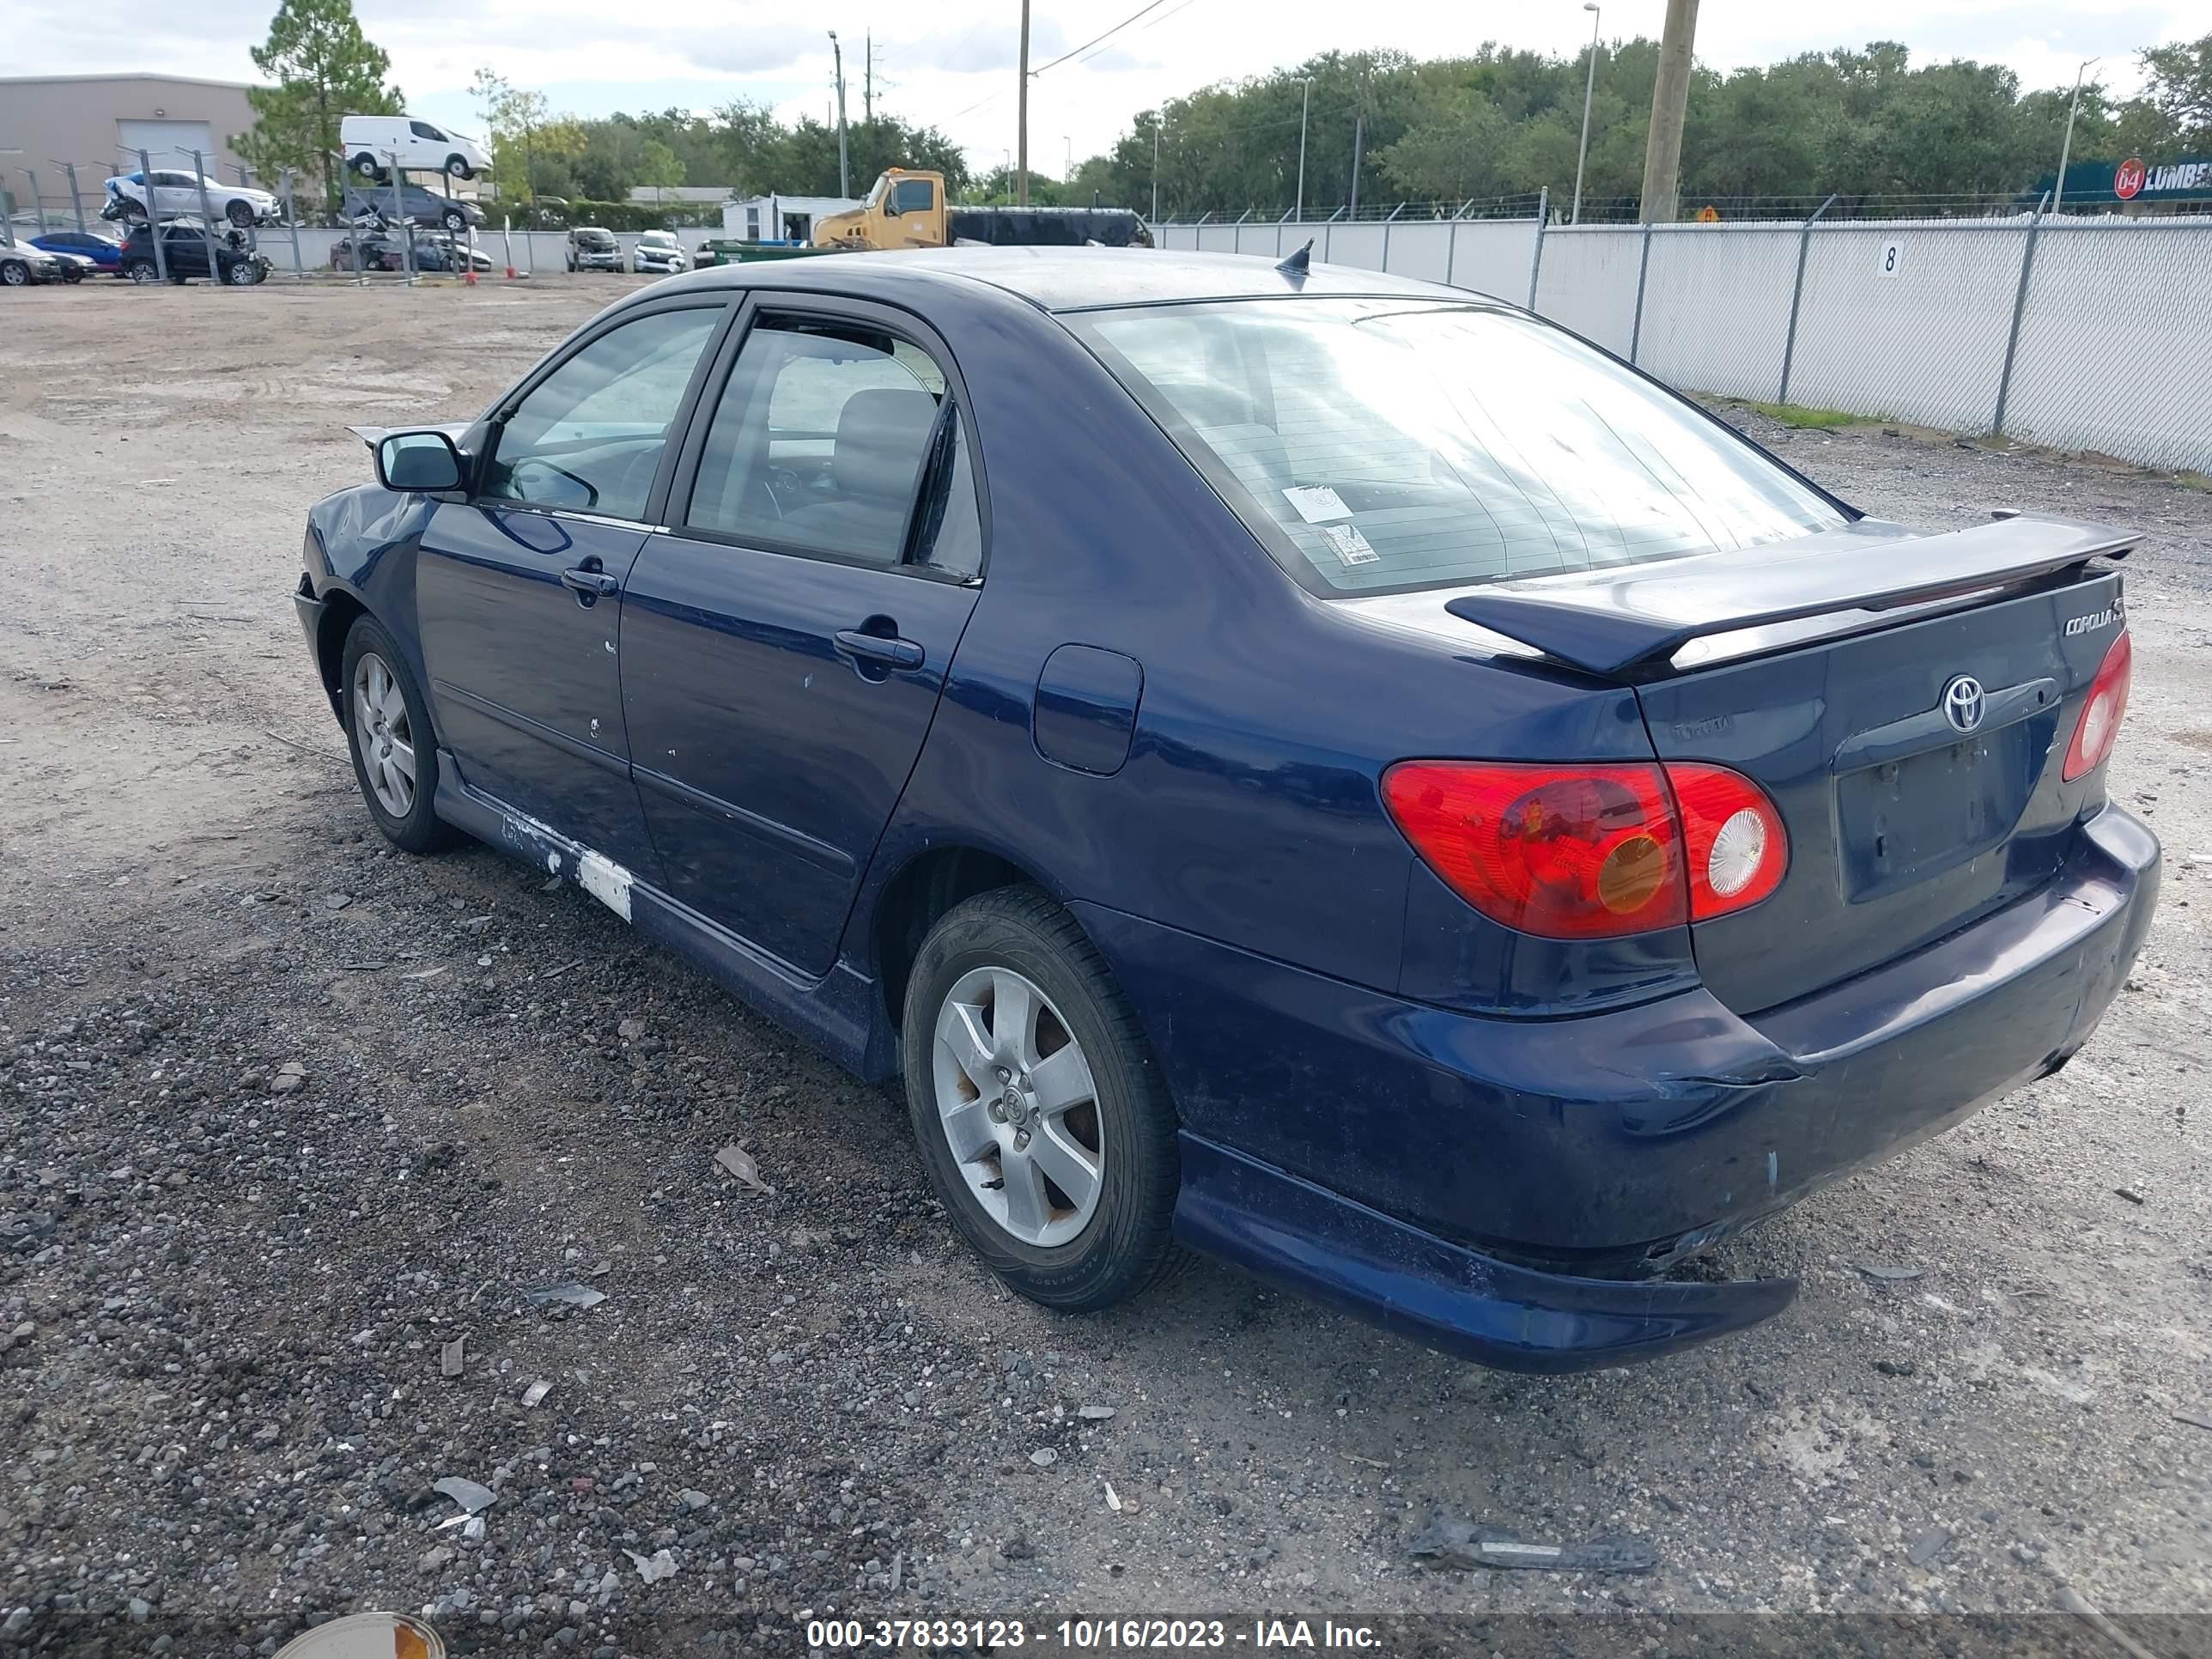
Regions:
[[677, 248, 1498, 312]]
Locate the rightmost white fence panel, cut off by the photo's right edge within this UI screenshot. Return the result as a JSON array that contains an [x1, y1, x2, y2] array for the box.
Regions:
[[2004, 216, 2212, 473]]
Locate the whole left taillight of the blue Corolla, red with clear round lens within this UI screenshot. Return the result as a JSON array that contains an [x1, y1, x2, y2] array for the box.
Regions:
[[1382, 761, 1790, 938]]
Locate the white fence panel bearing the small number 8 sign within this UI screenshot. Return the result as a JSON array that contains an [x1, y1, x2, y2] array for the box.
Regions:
[[1796, 219, 2028, 431]]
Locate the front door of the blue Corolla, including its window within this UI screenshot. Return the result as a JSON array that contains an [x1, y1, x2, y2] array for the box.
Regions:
[[416, 299, 728, 872]]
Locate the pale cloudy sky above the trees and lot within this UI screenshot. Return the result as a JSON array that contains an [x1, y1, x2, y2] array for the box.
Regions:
[[13, 0, 2205, 173]]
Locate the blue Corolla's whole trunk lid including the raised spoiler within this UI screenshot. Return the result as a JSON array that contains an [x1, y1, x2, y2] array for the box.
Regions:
[[1447, 518, 2135, 1013]]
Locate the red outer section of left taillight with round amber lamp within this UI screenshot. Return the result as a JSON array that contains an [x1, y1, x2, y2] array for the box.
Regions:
[[1382, 761, 1687, 938]]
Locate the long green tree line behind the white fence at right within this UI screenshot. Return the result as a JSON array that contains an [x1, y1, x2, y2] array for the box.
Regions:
[[1068, 35, 2212, 216]]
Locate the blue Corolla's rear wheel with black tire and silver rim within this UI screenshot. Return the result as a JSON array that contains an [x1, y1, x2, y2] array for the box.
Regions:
[[902, 887, 1182, 1314]]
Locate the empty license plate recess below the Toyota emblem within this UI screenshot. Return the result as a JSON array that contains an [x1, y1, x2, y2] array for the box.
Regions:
[[1836, 719, 2048, 900]]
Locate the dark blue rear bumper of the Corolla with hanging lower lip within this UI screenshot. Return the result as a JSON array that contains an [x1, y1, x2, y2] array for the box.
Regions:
[[1078, 807, 2159, 1370]]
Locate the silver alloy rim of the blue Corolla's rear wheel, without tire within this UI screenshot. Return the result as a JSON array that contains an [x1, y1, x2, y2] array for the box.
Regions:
[[929, 967, 1106, 1248]]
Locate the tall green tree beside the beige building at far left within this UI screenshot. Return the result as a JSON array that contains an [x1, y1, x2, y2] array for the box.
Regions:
[[230, 0, 400, 206]]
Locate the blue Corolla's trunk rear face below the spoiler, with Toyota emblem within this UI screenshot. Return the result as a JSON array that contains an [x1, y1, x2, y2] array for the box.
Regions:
[[1637, 570, 2121, 1013]]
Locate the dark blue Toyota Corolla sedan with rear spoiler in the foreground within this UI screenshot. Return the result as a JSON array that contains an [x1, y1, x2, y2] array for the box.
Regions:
[[299, 248, 2159, 1371]]
